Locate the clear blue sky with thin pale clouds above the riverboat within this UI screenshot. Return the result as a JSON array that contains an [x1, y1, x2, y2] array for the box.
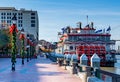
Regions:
[[0, 0, 120, 48]]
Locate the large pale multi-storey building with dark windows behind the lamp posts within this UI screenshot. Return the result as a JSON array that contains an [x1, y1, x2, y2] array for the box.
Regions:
[[0, 7, 39, 40]]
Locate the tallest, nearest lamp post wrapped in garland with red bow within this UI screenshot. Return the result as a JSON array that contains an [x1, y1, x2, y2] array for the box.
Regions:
[[9, 14, 18, 71]]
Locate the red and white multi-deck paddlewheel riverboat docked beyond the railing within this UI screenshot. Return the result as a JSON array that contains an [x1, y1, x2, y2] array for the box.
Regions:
[[58, 22, 115, 66]]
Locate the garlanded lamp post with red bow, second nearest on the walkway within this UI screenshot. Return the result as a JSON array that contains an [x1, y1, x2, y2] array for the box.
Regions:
[[19, 28, 25, 65]]
